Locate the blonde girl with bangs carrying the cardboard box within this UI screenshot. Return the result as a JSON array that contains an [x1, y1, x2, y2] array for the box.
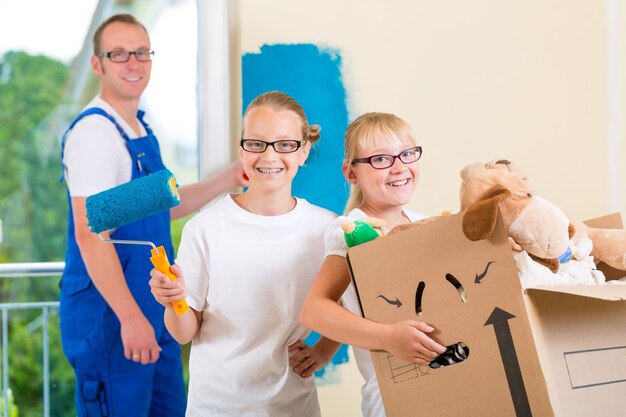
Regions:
[[300, 113, 445, 417]]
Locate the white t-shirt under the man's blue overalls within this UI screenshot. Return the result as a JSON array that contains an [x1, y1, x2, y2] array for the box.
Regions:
[[63, 96, 146, 197]]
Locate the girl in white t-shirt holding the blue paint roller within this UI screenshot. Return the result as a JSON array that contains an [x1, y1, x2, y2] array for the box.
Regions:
[[150, 92, 339, 417]]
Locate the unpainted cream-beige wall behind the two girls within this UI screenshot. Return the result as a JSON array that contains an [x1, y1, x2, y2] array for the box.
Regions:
[[234, 0, 626, 416]]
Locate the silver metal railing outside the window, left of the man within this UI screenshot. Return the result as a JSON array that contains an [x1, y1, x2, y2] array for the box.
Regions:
[[0, 262, 65, 417]]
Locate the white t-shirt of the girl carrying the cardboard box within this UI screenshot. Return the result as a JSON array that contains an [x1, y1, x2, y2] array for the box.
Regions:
[[324, 208, 427, 417]]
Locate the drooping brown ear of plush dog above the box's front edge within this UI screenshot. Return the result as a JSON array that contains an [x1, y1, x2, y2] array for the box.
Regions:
[[463, 184, 511, 241]]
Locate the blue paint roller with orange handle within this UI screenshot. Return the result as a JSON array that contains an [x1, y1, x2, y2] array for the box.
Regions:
[[86, 169, 189, 314]]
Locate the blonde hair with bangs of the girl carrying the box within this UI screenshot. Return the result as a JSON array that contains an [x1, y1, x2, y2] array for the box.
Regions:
[[343, 112, 417, 214]]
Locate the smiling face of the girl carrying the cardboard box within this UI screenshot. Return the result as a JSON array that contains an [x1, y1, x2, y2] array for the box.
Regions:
[[344, 134, 419, 211]]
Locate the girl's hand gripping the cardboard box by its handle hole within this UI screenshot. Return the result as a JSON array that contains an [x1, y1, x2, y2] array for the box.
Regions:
[[385, 320, 446, 365]]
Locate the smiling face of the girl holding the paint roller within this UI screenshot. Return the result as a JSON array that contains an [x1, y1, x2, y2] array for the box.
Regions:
[[239, 106, 310, 196]]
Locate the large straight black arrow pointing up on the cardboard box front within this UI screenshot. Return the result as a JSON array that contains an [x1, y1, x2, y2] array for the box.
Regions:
[[484, 307, 532, 417]]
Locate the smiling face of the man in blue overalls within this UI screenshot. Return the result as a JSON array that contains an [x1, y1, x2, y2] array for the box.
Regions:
[[91, 22, 152, 103]]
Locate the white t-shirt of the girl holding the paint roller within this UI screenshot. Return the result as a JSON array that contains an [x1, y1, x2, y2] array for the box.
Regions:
[[177, 195, 336, 417]]
